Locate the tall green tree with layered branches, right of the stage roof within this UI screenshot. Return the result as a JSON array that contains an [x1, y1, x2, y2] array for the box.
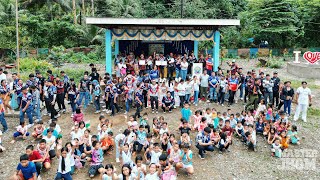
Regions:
[[251, 0, 303, 48]]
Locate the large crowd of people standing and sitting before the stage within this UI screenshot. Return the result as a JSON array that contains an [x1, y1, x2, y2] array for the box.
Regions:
[[0, 53, 312, 180]]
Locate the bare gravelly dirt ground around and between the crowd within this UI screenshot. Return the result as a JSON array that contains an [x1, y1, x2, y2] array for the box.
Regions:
[[0, 61, 320, 180]]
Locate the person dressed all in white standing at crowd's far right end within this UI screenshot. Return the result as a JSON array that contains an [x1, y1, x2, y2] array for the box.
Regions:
[[293, 81, 311, 122]]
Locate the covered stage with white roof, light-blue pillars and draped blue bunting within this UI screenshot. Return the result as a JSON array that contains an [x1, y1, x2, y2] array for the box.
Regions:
[[86, 17, 240, 73]]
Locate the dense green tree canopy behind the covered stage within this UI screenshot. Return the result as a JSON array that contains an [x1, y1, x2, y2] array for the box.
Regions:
[[0, 0, 320, 49]]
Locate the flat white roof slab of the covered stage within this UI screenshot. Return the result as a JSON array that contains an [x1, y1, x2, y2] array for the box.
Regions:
[[86, 17, 240, 30]]
